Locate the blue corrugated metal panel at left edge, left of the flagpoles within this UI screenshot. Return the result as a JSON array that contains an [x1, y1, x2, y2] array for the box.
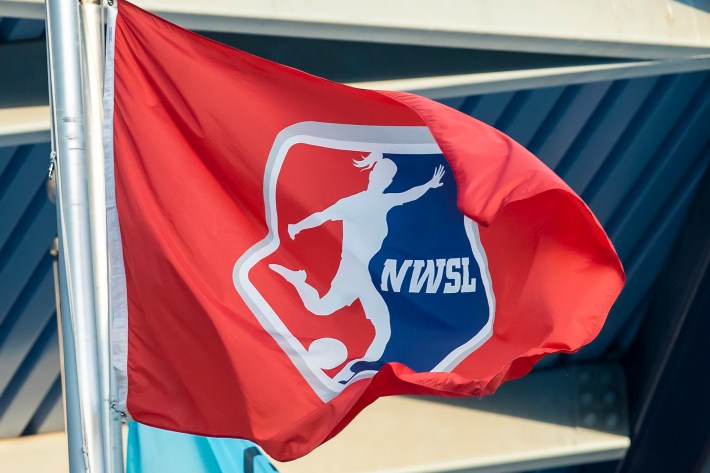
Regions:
[[0, 143, 63, 437]]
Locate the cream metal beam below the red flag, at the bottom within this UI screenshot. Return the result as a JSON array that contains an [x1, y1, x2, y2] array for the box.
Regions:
[[0, 364, 629, 473]]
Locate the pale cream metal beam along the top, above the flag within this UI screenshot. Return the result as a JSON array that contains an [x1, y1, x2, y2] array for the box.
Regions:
[[0, 0, 710, 59]]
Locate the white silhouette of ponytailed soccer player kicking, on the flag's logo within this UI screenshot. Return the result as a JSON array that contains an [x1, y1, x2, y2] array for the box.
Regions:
[[269, 153, 444, 382]]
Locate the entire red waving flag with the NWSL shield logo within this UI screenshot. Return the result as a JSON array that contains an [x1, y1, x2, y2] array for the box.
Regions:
[[108, 2, 624, 460]]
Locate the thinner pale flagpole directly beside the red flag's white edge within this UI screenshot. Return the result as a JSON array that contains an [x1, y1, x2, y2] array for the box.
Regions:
[[80, 0, 123, 473]]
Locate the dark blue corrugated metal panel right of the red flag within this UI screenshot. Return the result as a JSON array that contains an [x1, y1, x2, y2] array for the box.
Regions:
[[454, 71, 710, 366]]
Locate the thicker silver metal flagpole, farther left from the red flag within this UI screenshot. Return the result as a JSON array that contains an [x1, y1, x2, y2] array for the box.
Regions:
[[46, 0, 106, 473]]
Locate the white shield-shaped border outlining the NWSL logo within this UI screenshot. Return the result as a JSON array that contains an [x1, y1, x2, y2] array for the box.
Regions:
[[232, 122, 495, 402]]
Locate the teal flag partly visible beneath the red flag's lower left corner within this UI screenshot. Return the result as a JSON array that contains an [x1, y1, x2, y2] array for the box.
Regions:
[[126, 422, 277, 473]]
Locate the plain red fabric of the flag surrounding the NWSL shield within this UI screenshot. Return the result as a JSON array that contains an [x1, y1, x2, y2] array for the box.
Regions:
[[114, 2, 624, 460]]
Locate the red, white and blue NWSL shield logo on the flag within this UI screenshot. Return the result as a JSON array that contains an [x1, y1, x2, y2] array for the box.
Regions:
[[233, 122, 495, 401]]
